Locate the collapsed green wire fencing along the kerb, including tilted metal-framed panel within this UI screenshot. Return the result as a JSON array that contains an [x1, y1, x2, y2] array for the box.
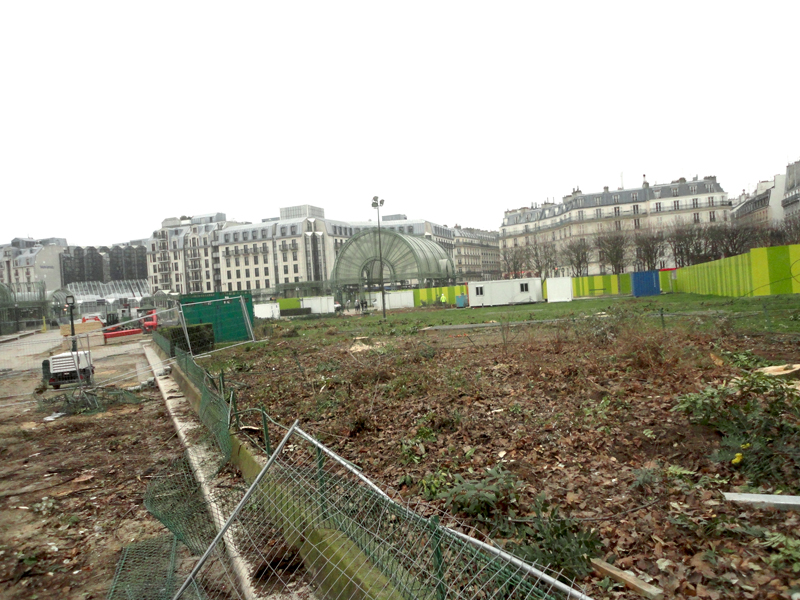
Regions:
[[109, 330, 586, 600]]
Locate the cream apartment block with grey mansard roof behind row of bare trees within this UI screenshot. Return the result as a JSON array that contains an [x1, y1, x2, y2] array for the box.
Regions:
[[500, 176, 731, 275]]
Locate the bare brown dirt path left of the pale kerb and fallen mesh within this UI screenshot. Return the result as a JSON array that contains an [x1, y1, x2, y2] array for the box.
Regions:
[[0, 345, 181, 600]]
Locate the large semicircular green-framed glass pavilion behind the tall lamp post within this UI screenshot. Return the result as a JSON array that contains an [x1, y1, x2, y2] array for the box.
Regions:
[[331, 228, 455, 287]]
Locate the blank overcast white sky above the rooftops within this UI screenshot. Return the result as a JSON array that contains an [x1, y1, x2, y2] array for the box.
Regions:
[[0, 0, 800, 245]]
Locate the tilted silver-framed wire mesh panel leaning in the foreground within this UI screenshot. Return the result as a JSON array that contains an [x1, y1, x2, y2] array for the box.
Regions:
[[175, 428, 586, 600]]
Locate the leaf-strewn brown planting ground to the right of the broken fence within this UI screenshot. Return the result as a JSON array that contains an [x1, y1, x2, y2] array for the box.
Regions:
[[205, 321, 800, 598]]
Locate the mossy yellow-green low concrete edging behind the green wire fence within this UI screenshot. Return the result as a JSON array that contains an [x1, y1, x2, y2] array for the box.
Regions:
[[148, 346, 403, 600]]
